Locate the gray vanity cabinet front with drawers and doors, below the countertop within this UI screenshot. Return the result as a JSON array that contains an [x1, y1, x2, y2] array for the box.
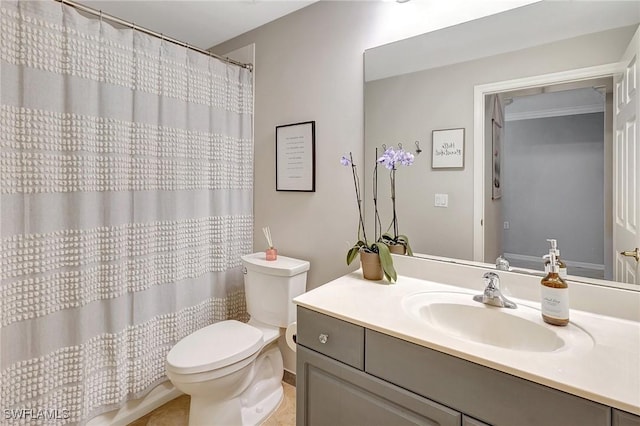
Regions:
[[296, 307, 628, 426]]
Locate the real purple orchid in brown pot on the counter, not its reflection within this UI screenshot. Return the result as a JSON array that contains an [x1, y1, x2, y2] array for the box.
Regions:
[[340, 153, 398, 282]]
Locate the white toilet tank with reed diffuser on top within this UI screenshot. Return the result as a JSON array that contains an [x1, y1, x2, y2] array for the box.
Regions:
[[242, 252, 310, 327]]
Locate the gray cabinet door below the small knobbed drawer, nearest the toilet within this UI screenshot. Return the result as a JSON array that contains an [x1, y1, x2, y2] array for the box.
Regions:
[[296, 346, 462, 426]]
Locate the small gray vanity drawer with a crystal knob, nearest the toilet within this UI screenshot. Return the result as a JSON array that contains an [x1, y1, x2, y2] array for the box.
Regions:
[[296, 307, 364, 370]]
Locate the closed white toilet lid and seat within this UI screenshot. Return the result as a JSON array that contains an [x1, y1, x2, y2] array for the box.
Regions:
[[167, 320, 263, 374]]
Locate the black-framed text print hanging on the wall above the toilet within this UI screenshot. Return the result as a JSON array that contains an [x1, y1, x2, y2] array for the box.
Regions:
[[276, 121, 316, 192]]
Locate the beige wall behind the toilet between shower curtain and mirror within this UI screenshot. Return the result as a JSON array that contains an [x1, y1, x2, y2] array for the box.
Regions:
[[215, 2, 375, 289]]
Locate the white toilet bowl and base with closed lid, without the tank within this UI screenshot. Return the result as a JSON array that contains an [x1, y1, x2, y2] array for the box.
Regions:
[[166, 320, 284, 426]]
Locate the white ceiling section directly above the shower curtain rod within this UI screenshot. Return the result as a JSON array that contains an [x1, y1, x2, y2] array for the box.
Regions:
[[76, 0, 316, 49]]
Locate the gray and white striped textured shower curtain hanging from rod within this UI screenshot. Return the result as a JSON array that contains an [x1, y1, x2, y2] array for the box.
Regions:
[[0, 1, 253, 424]]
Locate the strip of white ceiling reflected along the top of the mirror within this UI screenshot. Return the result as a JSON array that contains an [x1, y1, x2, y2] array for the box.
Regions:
[[365, 0, 640, 81]]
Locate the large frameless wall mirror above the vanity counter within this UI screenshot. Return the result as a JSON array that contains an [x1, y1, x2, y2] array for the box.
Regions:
[[364, 1, 640, 289]]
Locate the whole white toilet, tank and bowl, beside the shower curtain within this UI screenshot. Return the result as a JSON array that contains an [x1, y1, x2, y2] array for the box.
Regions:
[[166, 252, 309, 426]]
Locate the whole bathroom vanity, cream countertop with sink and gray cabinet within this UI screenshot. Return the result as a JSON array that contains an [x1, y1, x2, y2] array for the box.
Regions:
[[295, 256, 640, 426]]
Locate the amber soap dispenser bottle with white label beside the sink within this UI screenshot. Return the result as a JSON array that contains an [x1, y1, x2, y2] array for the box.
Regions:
[[540, 248, 569, 326]]
